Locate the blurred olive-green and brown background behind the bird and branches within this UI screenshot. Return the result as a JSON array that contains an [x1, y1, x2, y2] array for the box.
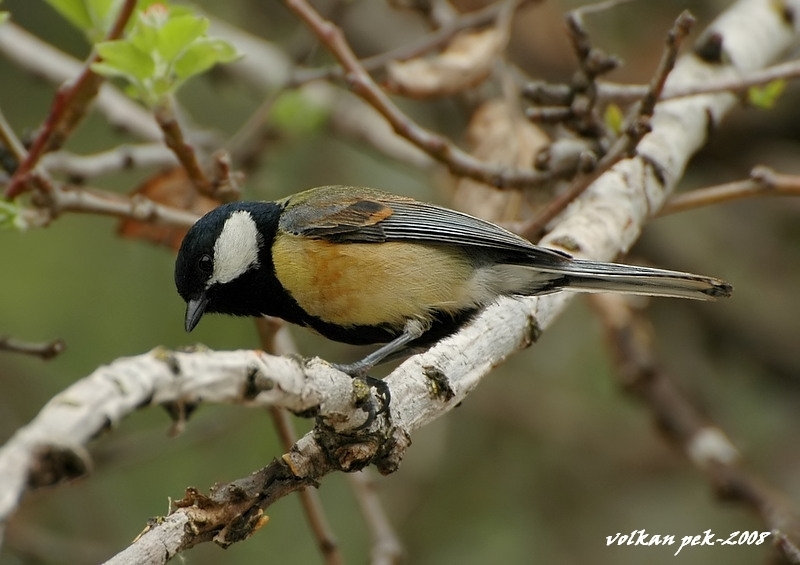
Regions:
[[0, 0, 800, 565]]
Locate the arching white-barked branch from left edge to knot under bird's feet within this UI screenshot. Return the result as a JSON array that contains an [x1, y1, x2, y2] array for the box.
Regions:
[[0, 349, 366, 524]]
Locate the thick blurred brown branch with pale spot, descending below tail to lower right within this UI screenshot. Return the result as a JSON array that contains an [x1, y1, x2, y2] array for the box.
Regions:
[[592, 295, 800, 563]]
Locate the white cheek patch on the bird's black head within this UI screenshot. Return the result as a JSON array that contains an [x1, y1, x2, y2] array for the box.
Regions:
[[206, 210, 263, 287]]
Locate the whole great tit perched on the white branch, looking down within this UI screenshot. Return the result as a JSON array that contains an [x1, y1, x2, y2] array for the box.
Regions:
[[175, 186, 732, 374]]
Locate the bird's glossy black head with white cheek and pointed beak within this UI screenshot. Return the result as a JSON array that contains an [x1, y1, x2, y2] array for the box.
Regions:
[[175, 202, 280, 331]]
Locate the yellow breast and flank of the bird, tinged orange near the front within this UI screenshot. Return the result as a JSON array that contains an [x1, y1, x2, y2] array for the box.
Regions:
[[272, 234, 473, 327]]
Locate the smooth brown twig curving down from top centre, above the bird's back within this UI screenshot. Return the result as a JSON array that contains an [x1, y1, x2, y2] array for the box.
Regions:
[[285, 0, 554, 188]]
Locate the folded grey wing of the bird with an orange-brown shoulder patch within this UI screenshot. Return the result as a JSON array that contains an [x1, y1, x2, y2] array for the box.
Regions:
[[280, 189, 569, 263]]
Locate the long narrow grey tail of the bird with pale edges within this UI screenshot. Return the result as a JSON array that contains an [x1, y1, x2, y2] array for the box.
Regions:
[[542, 259, 733, 300]]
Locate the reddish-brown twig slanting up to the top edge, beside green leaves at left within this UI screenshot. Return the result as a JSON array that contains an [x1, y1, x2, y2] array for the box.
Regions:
[[5, 0, 136, 199]]
